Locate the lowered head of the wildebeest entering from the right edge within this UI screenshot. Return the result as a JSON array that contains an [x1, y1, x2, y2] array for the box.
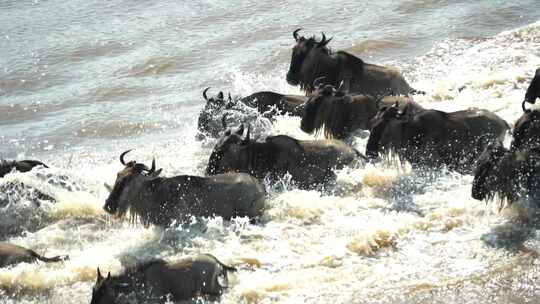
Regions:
[[471, 142, 506, 200]]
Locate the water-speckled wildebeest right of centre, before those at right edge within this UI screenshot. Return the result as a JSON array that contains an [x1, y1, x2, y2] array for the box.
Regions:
[[366, 107, 510, 173]]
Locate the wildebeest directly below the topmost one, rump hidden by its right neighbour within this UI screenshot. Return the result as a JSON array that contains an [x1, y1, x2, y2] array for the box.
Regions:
[[300, 81, 423, 139]]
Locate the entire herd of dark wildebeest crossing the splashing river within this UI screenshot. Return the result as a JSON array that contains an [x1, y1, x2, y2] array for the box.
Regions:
[[0, 29, 540, 304]]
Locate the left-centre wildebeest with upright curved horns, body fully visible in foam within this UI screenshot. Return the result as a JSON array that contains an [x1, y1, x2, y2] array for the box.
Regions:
[[103, 150, 266, 226]]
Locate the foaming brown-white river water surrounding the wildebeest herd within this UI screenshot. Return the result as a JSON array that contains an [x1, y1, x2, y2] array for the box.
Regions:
[[0, 0, 540, 303]]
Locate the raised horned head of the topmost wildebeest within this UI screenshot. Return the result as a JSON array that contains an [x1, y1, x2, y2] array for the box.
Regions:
[[287, 29, 332, 91]]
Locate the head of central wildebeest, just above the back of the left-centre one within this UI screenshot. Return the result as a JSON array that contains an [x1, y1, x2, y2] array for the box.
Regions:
[[206, 124, 251, 175]]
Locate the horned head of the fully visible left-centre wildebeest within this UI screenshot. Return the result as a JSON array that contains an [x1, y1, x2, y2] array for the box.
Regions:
[[103, 150, 161, 215]]
